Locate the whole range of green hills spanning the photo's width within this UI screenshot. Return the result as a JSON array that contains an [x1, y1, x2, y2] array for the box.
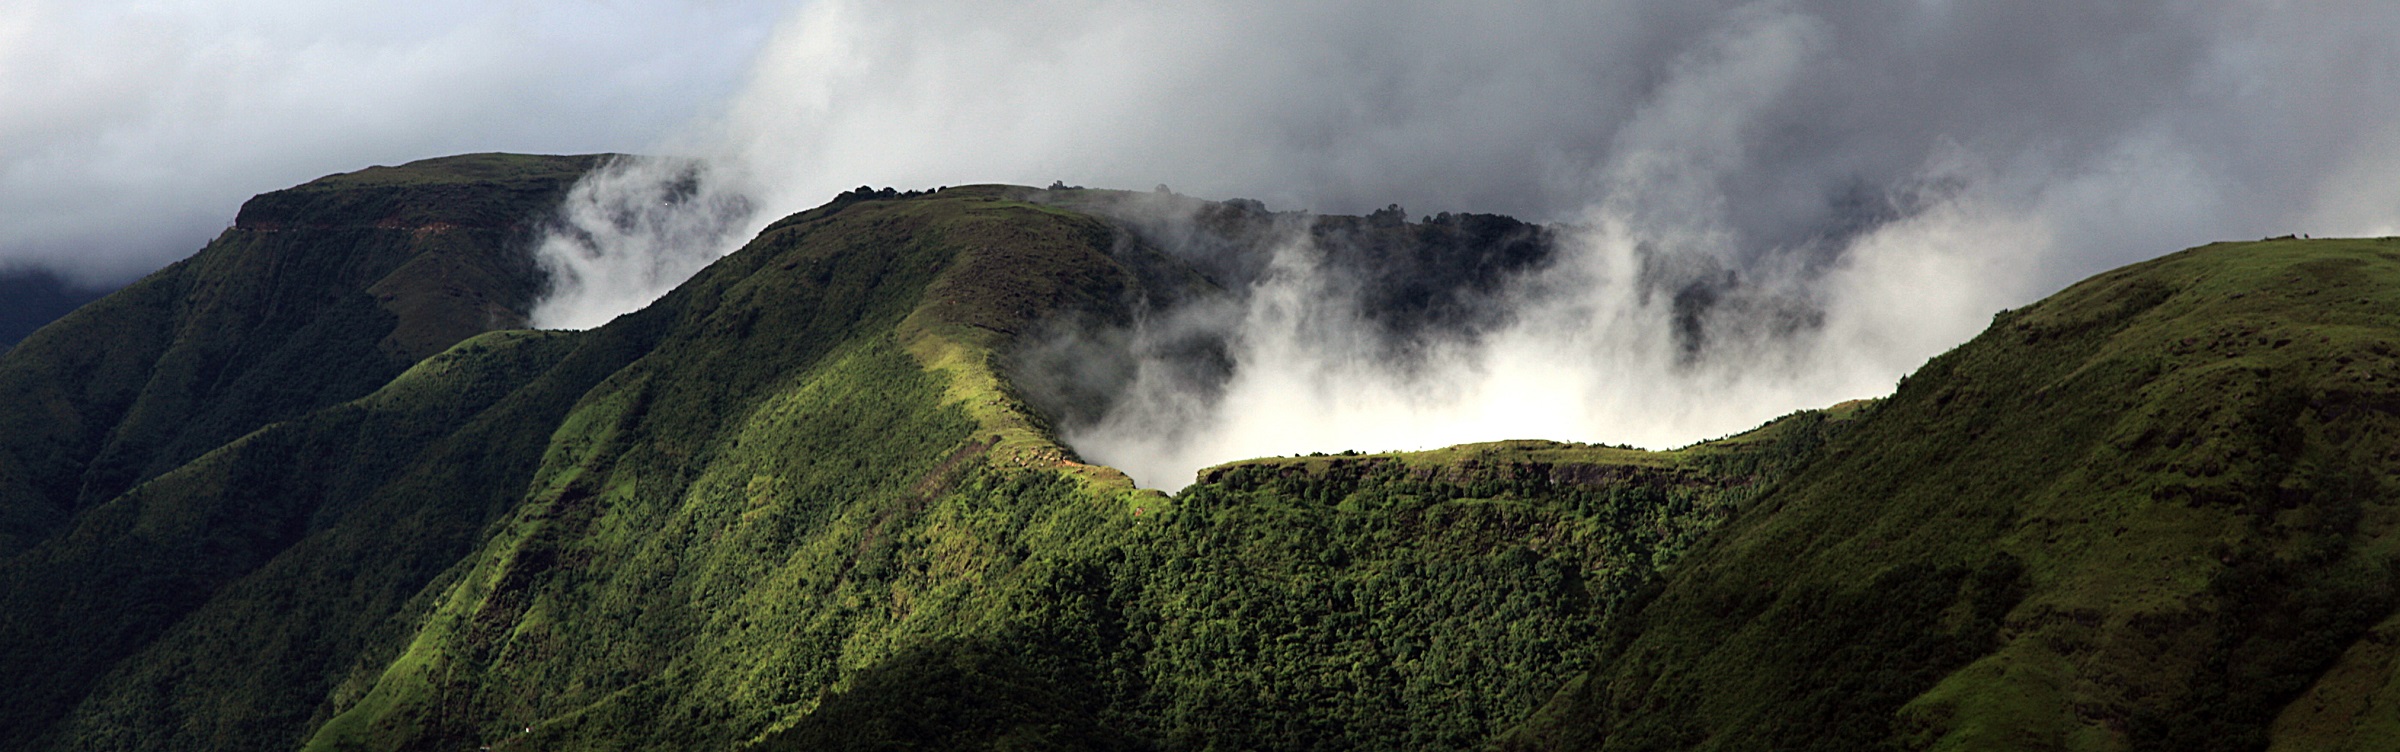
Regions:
[[0, 156, 2400, 750]]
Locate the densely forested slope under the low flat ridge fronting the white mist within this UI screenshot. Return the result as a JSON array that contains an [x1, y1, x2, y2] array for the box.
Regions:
[[744, 413, 1846, 750]]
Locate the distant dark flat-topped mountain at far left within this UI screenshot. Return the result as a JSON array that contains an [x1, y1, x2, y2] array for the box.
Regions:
[[0, 154, 598, 557]]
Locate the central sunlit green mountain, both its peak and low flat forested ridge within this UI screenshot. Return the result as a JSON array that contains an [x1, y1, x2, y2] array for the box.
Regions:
[[280, 187, 1834, 750]]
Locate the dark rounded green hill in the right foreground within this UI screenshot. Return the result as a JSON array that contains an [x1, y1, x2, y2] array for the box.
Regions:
[[1514, 240, 2400, 750]]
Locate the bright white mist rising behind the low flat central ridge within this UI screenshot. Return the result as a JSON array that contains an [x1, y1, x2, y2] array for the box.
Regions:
[[1060, 160, 2054, 488]]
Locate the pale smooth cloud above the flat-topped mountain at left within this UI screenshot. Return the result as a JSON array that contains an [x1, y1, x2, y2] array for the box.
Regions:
[[0, 0, 782, 284]]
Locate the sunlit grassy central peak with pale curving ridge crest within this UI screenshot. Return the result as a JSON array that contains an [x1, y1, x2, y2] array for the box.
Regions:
[[295, 187, 1166, 747]]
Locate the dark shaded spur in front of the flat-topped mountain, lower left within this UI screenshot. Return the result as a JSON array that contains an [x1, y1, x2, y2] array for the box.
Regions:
[[28, 326, 624, 750]]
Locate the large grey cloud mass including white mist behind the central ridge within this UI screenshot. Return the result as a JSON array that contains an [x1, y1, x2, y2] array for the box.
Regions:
[[540, 0, 2400, 488]]
